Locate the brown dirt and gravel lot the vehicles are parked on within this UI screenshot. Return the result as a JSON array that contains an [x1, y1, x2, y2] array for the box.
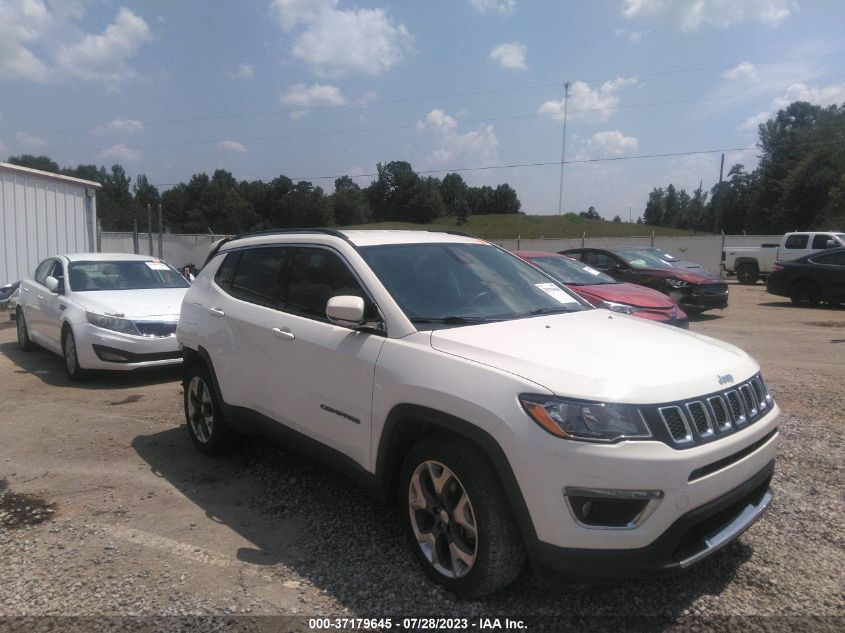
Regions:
[[0, 285, 845, 630]]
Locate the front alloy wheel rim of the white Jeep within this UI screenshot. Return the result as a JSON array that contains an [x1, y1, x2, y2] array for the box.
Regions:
[[408, 460, 478, 578]]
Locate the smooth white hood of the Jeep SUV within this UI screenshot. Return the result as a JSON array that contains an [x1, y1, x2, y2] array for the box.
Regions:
[[431, 310, 759, 404]]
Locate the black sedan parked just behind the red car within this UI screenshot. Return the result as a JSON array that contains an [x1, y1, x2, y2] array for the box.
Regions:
[[560, 248, 728, 313]]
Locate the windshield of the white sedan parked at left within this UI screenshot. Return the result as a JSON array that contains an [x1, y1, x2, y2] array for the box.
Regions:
[[68, 260, 190, 292]]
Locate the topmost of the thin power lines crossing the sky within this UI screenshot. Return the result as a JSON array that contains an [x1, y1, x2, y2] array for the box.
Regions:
[[28, 51, 845, 134]]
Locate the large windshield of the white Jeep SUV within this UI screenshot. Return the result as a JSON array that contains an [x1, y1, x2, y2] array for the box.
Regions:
[[359, 243, 588, 327]]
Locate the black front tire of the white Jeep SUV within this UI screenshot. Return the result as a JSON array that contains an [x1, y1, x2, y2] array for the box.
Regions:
[[398, 437, 525, 598]]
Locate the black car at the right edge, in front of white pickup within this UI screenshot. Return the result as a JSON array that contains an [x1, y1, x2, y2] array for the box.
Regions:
[[766, 248, 845, 306]]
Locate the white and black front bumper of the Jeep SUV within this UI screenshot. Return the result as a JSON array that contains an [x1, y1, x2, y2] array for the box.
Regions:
[[494, 403, 780, 575]]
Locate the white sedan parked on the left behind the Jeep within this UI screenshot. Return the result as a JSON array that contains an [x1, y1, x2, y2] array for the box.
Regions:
[[16, 253, 189, 380]]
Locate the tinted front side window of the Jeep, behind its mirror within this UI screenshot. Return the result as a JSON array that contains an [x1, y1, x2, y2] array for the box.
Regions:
[[285, 248, 376, 320]]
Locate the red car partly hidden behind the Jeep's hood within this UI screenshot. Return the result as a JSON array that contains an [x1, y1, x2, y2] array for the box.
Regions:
[[514, 251, 689, 329]]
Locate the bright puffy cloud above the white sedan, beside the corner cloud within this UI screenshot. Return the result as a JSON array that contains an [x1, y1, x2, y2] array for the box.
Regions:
[[56, 7, 152, 85]]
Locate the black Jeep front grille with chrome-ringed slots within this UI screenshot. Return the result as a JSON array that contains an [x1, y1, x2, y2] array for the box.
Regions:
[[641, 374, 773, 448]]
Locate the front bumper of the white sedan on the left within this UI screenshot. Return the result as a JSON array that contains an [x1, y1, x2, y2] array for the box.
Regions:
[[73, 324, 182, 371]]
